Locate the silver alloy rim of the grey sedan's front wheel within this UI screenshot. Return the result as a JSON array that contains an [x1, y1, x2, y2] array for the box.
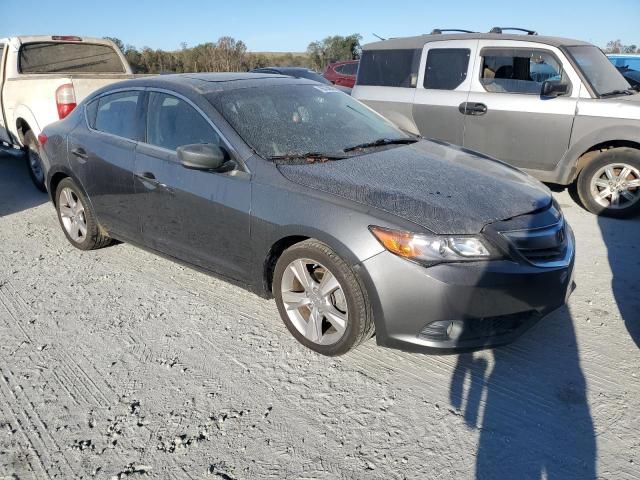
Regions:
[[281, 259, 348, 345]]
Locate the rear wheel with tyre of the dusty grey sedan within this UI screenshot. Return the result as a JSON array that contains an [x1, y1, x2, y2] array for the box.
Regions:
[[54, 178, 112, 250]]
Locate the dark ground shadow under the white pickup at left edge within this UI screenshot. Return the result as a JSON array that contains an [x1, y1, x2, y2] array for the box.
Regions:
[[0, 148, 49, 217]]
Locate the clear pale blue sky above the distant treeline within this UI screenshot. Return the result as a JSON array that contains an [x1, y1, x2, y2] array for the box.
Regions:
[[0, 0, 640, 51]]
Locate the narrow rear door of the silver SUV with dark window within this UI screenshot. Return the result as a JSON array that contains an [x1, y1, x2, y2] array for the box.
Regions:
[[413, 40, 478, 145]]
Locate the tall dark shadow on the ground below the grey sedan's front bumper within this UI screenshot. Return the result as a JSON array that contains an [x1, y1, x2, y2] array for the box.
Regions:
[[449, 209, 597, 480]]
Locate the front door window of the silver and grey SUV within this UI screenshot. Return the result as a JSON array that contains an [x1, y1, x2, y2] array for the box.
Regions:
[[480, 49, 565, 95]]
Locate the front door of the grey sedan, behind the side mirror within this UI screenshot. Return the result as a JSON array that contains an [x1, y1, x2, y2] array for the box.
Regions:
[[135, 91, 251, 280]]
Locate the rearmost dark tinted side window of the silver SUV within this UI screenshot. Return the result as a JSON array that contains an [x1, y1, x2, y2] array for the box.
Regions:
[[356, 50, 421, 88]]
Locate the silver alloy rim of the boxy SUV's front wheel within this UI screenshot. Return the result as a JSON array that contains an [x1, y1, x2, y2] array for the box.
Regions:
[[591, 163, 640, 210]]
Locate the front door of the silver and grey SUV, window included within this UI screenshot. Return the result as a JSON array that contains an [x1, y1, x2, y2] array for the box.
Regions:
[[463, 40, 581, 172]]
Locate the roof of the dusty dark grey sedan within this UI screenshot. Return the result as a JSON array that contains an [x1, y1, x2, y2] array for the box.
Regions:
[[92, 72, 317, 97]]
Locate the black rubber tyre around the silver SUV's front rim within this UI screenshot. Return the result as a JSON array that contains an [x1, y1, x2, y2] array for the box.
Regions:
[[576, 147, 640, 218]]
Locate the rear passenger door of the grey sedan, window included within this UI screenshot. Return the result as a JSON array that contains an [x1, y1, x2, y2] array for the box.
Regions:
[[68, 89, 144, 242]]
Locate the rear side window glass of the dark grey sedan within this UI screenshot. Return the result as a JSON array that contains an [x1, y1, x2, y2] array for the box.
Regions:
[[93, 91, 140, 140]]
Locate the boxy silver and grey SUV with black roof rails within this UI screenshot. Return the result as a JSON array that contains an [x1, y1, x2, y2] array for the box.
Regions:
[[353, 28, 640, 217]]
